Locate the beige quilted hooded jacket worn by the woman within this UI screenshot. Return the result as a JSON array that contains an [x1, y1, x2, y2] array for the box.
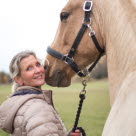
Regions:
[[0, 86, 67, 136]]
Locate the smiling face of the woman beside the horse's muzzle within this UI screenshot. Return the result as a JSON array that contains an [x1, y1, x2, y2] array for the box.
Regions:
[[15, 55, 45, 88]]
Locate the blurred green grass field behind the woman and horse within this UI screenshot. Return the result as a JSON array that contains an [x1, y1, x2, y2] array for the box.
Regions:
[[0, 80, 110, 136]]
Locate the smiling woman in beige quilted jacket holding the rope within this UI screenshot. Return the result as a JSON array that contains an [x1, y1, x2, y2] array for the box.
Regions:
[[0, 51, 80, 136]]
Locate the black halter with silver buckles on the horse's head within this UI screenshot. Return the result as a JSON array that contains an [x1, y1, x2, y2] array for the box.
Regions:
[[47, 0, 104, 77]]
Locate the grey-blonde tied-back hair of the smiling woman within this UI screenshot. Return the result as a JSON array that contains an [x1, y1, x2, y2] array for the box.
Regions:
[[9, 50, 37, 92]]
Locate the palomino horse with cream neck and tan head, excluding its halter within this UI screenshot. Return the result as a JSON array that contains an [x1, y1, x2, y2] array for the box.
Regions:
[[45, 0, 136, 136]]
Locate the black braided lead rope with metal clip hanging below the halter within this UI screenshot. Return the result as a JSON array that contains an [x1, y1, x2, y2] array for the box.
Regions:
[[69, 80, 87, 136]]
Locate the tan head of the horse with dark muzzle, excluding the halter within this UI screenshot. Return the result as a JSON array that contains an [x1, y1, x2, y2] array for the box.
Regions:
[[45, 0, 103, 87]]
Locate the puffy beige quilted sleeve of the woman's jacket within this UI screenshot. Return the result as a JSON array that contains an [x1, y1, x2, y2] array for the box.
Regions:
[[20, 99, 62, 136]]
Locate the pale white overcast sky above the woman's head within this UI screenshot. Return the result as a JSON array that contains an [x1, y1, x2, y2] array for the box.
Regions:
[[0, 0, 67, 72]]
